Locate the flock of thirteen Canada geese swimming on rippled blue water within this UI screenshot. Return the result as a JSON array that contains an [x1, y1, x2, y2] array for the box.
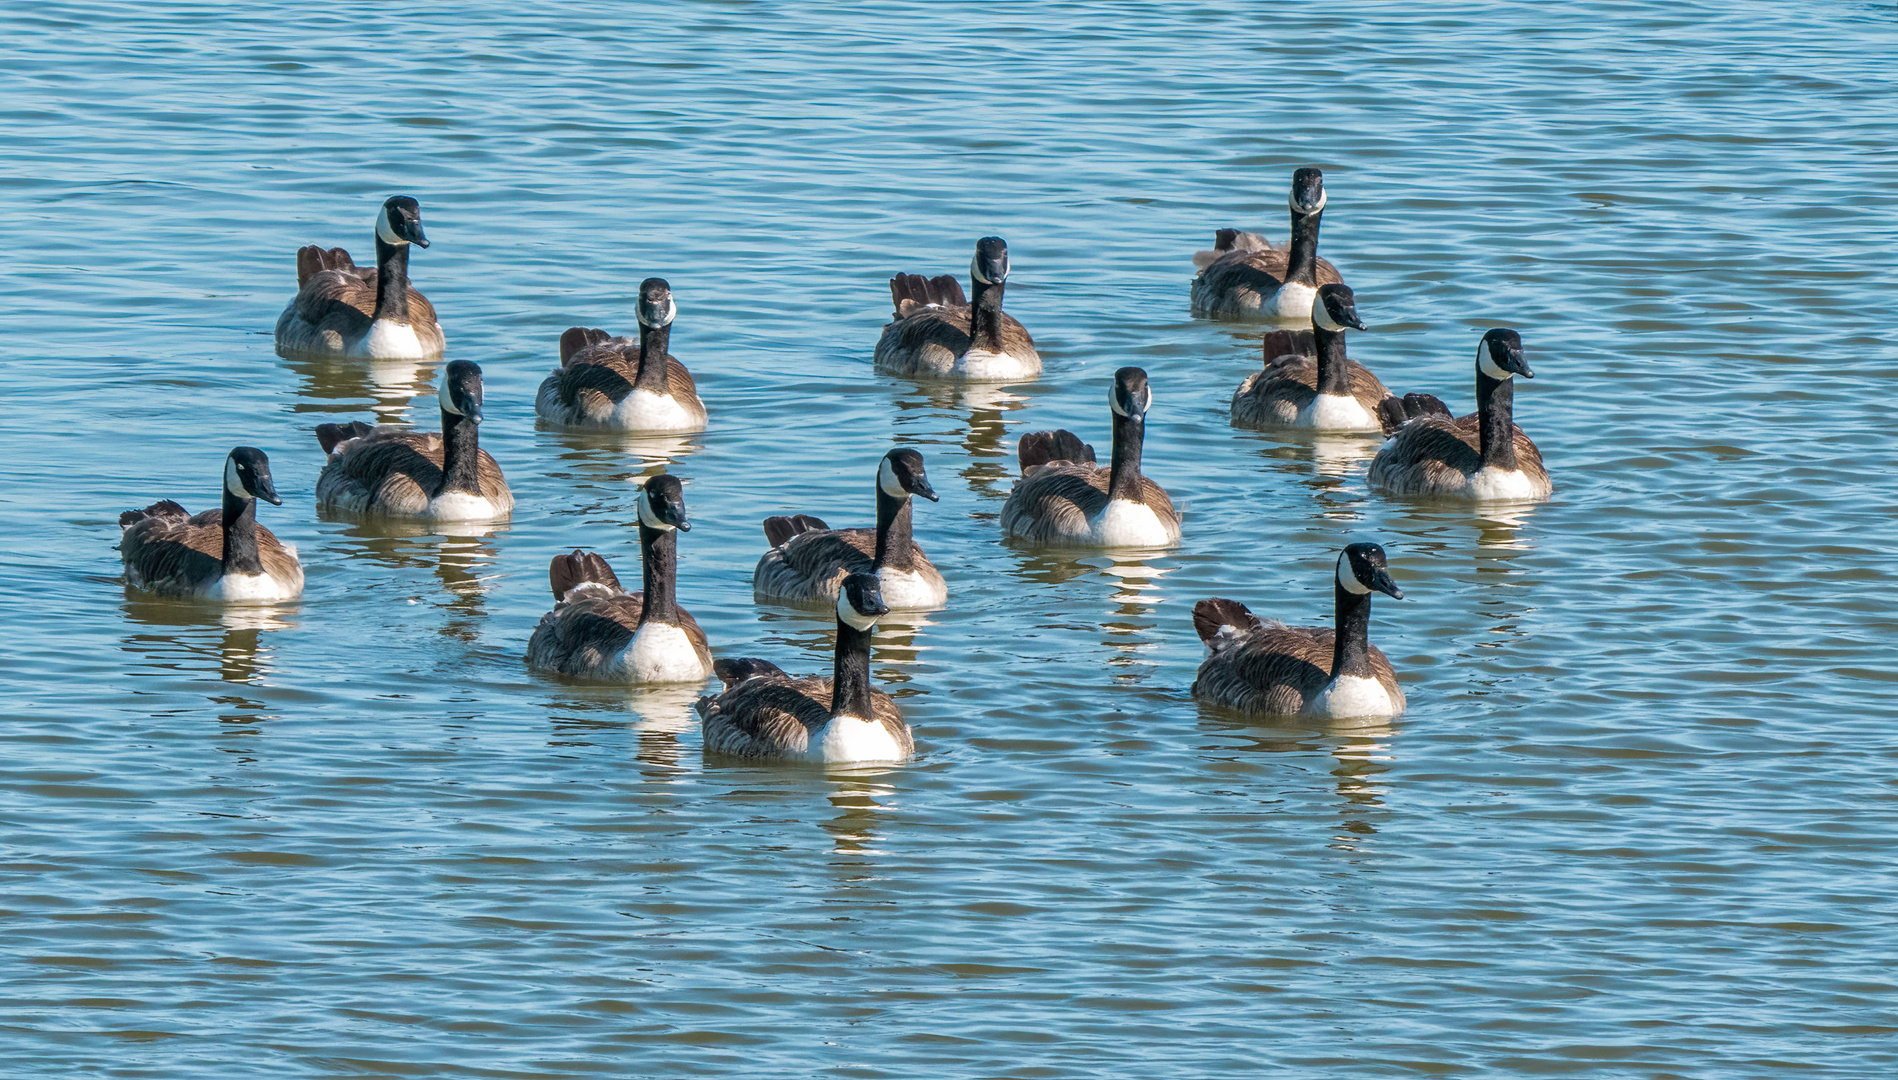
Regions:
[[120, 169, 1551, 763]]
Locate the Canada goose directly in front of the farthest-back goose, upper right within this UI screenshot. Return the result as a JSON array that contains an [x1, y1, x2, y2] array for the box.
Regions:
[[1232, 285, 1391, 431]]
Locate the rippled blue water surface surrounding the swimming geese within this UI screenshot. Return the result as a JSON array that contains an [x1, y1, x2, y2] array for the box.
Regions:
[[0, 0, 1898, 1080]]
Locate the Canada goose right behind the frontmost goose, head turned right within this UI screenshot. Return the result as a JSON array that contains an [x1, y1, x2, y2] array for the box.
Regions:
[[752, 446, 949, 611]]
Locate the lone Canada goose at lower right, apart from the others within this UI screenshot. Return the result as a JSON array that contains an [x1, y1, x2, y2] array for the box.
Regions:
[[1192, 543, 1405, 717]]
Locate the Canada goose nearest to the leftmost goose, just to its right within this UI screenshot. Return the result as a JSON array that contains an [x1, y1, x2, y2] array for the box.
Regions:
[[317, 361, 514, 522]]
